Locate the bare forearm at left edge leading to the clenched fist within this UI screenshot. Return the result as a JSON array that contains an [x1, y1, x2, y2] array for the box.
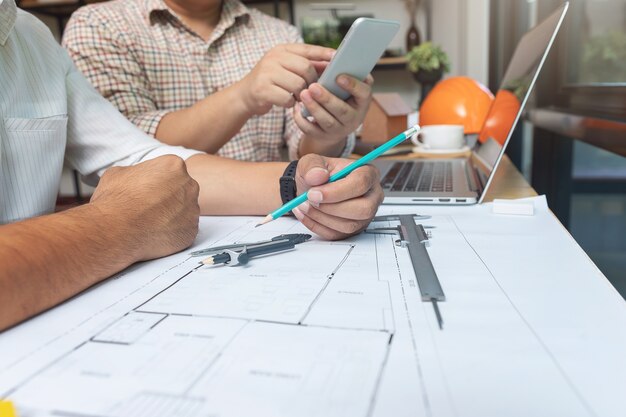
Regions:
[[0, 204, 138, 330]]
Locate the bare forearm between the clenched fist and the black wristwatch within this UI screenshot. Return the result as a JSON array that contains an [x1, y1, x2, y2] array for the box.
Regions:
[[186, 155, 287, 215]]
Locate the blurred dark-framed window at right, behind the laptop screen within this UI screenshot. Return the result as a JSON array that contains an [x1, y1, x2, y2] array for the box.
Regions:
[[516, 0, 626, 298]]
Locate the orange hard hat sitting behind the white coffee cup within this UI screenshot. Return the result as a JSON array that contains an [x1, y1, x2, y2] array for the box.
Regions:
[[419, 77, 493, 134]]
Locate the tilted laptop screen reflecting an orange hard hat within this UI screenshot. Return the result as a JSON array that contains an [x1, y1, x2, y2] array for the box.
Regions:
[[474, 3, 568, 202]]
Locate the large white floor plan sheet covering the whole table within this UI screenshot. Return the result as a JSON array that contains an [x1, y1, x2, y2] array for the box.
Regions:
[[0, 197, 624, 417]]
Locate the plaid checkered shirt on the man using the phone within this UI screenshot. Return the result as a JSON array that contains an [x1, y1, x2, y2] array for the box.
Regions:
[[63, 0, 353, 161]]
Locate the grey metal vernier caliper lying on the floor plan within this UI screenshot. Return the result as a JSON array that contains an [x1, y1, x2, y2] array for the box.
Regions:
[[366, 214, 446, 329]]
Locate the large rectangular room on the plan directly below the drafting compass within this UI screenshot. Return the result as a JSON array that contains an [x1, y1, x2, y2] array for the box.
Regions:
[[139, 242, 352, 324]]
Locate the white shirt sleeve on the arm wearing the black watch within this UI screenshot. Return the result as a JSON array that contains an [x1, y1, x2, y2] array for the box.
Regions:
[[59, 47, 203, 184]]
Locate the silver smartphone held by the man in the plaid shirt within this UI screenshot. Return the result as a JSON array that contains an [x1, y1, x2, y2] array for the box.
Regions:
[[301, 17, 400, 117]]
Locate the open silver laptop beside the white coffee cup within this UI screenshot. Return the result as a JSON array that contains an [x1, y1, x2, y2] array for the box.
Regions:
[[374, 2, 569, 205]]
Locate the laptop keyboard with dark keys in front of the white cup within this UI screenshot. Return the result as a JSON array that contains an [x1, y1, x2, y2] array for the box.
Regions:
[[381, 161, 453, 192]]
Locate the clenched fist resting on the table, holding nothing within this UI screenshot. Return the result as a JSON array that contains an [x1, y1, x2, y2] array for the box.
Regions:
[[91, 155, 200, 261]]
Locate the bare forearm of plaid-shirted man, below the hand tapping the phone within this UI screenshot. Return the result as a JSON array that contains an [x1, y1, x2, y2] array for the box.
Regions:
[[155, 84, 252, 154]]
